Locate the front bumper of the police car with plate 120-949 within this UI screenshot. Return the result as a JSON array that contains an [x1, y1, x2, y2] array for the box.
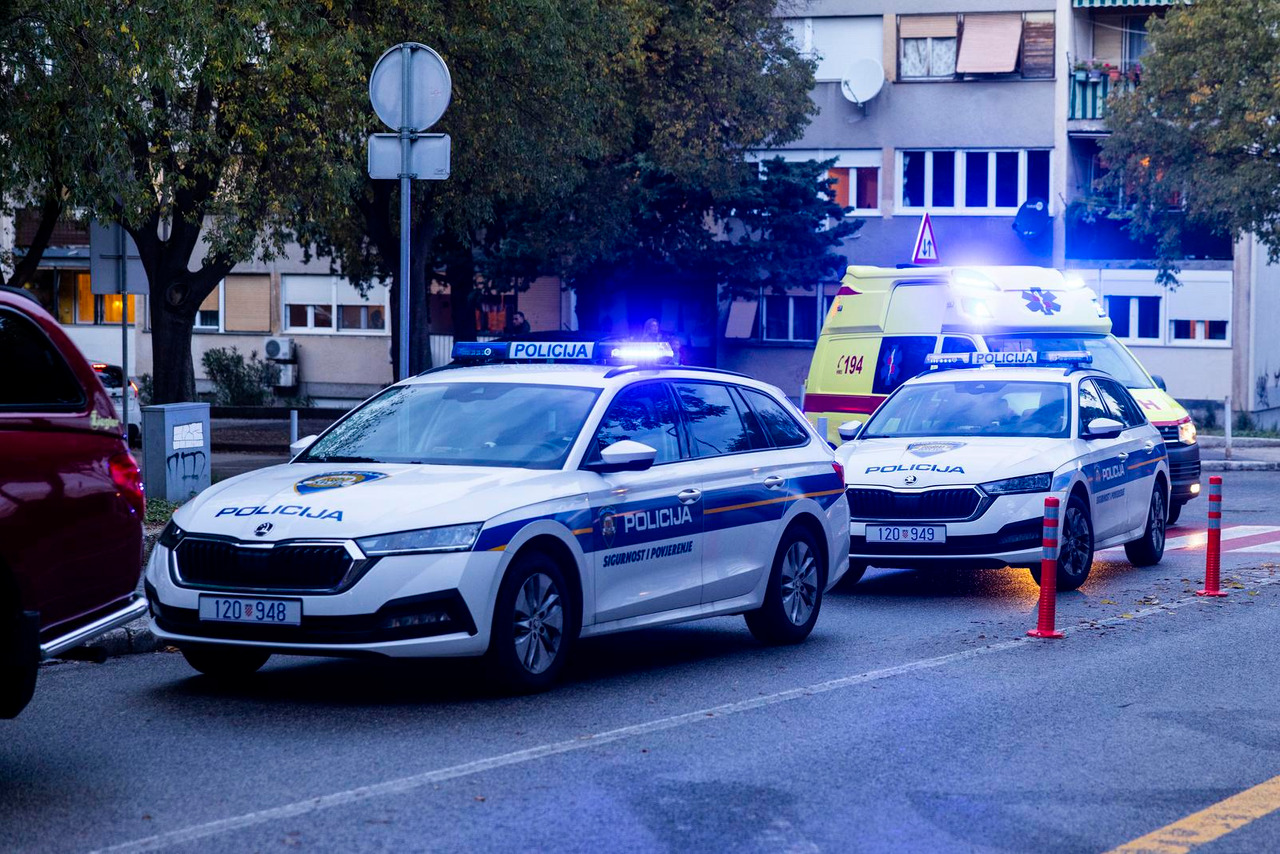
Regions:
[[849, 493, 1049, 568]]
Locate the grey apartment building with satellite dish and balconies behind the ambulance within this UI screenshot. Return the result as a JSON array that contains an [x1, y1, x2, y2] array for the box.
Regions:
[[732, 0, 1280, 421]]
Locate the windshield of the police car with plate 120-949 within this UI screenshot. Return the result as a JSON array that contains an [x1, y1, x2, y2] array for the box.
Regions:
[[859, 378, 1070, 439]]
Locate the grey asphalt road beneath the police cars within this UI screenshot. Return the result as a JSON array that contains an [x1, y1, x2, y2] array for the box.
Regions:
[[0, 472, 1280, 851]]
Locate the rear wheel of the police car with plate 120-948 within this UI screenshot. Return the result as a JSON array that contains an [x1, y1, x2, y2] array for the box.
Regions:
[[742, 525, 827, 645]]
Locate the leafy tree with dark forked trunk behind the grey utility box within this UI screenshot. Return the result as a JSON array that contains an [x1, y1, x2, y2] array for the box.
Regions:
[[19, 0, 366, 403]]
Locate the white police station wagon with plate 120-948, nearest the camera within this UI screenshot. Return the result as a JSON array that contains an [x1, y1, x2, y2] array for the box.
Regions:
[[146, 342, 849, 690]]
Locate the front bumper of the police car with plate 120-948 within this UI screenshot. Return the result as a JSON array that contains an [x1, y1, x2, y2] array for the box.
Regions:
[[146, 545, 502, 658]]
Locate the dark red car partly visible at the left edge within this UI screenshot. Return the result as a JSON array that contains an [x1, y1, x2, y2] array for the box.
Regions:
[[0, 288, 146, 717]]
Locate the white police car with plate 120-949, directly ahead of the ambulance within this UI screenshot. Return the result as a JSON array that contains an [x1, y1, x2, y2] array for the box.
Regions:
[[837, 352, 1170, 590]]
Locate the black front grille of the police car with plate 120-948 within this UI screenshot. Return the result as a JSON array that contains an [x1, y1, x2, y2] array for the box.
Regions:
[[177, 536, 355, 590]]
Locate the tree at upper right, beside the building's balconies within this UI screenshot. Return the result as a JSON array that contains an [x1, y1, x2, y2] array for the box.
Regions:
[[1102, 0, 1280, 283]]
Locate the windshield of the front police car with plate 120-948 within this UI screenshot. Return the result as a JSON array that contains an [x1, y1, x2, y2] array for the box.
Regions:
[[297, 383, 599, 469]]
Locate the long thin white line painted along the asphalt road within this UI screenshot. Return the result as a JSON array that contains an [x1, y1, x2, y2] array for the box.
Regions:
[[93, 572, 1280, 854]]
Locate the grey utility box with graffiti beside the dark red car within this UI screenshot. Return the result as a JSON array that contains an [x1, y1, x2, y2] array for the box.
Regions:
[[142, 403, 212, 502]]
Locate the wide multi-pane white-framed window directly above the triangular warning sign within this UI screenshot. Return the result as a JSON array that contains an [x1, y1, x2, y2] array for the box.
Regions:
[[899, 150, 1050, 215]]
